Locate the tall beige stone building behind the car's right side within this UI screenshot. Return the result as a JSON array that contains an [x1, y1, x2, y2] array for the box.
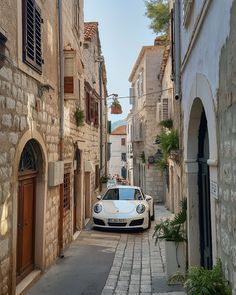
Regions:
[[129, 45, 164, 201]]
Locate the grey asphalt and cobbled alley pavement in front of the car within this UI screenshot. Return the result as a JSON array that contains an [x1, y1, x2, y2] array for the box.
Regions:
[[26, 206, 185, 295]]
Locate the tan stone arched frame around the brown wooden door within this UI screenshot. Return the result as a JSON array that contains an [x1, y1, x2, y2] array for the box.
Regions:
[[12, 130, 48, 290]]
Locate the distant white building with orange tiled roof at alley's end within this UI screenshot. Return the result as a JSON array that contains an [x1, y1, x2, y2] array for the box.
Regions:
[[109, 125, 127, 179]]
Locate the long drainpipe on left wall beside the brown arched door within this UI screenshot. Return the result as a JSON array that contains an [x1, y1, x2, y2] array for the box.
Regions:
[[58, 0, 64, 258]]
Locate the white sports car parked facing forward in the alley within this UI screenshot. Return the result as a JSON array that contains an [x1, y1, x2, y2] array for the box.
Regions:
[[92, 185, 154, 229]]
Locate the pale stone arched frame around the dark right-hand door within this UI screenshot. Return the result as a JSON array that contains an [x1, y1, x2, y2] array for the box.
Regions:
[[184, 74, 218, 266]]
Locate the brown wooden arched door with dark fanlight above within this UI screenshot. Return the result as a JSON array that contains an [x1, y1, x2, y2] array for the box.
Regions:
[[16, 140, 38, 283]]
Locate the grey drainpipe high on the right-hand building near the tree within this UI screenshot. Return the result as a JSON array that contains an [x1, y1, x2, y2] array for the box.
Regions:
[[174, 0, 181, 99]]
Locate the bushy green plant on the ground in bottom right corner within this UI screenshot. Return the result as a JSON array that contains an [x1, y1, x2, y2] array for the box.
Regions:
[[184, 259, 232, 295]]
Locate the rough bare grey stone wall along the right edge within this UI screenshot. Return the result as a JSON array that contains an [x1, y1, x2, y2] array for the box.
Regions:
[[217, 1, 236, 295]]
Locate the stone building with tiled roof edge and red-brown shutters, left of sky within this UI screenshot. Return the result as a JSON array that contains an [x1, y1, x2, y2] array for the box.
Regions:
[[82, 22, 107, 210]]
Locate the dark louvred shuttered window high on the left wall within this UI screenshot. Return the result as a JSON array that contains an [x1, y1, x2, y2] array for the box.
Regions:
[[22, 0, 43, 74]]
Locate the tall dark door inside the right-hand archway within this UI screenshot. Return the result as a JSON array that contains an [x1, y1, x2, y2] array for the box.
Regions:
[[198, 109, 212, 269]]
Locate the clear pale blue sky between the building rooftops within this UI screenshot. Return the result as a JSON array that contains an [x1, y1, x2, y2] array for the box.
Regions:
[[84, 0, 155, 122]]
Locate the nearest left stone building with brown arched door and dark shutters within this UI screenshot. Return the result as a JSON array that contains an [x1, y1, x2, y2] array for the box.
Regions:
[[0, 0, 106, 294]]
